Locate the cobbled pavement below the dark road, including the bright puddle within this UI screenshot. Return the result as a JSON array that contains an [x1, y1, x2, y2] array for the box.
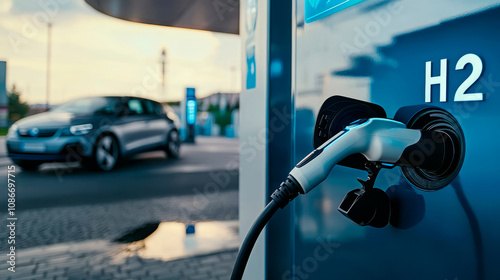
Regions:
[[0, 195, 238, 280]]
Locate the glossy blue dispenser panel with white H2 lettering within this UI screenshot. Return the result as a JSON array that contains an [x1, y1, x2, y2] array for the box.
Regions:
[[292, 0, 500, 280]]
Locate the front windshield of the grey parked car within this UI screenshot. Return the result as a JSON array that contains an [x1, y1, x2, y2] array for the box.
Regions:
[[53, 97, 116, 115]]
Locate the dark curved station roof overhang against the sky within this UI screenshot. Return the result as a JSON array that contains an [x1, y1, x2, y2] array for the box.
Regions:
[[85, 0, 240, 34]]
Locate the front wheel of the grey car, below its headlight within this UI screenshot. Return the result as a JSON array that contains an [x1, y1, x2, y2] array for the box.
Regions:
[[92, 135, 119, 171]]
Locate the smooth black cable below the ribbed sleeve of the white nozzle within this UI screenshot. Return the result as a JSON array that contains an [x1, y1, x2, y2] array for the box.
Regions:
[[231, 200, 279, 280]]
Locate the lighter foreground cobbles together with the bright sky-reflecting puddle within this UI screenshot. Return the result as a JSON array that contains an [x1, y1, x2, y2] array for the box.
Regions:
[[0, 220, 238, 280]]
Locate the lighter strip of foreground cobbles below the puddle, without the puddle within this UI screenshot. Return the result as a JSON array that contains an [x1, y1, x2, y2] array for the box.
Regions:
[[0, 241, 237, 280]]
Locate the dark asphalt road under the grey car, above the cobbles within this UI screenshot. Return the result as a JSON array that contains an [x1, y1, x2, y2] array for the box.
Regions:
[[0, 137, 239, 211]]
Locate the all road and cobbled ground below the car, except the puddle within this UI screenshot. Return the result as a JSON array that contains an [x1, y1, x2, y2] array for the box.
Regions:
[[0, 138, 242, 280]]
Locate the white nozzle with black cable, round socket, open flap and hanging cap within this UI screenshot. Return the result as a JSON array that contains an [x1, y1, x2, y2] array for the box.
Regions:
[[231, 96, 465, 280]]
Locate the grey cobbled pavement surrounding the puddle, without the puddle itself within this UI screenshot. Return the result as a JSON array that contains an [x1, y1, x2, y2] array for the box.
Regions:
[[0, 191, 238, 280]]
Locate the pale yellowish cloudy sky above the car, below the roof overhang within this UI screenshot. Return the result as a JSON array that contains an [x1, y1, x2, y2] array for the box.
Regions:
[[0, 0, 241, 104]]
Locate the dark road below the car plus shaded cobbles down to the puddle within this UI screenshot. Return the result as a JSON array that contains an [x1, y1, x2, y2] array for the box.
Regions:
[[0, 138, 239, 249]]
